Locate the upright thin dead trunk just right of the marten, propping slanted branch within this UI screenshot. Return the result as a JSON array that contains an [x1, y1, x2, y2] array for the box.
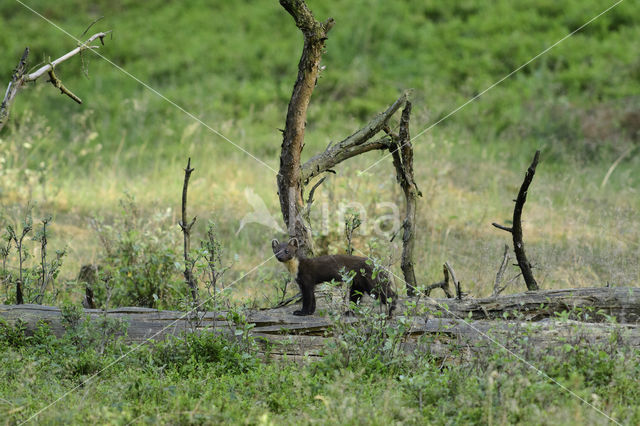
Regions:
[[387, 101, 422, 297]]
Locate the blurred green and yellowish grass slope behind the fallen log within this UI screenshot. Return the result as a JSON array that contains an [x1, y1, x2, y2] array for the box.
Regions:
[[0, 0, 640, 303]]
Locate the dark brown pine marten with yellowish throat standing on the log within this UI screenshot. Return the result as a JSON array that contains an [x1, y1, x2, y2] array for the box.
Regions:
[[271, 238, 396, 316]]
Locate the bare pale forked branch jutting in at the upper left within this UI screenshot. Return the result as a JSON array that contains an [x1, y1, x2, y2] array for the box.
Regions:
[[0, 31, 110, 130]]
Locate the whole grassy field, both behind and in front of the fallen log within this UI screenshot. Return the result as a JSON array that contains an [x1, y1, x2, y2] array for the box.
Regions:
[[0, 0, 640, 424]]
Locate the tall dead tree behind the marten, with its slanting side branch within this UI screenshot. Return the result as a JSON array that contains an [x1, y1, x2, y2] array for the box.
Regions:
[[277, 0, 407, 253]]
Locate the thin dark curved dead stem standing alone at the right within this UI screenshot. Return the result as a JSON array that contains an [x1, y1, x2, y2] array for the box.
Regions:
[[492, 150, 540, 291]]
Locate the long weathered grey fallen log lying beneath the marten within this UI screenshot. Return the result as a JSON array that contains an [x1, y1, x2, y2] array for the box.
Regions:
[[0, 288, 640, 360]]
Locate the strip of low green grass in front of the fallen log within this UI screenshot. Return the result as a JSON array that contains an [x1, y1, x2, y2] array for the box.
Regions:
[[0, 308, 640, 425]]
